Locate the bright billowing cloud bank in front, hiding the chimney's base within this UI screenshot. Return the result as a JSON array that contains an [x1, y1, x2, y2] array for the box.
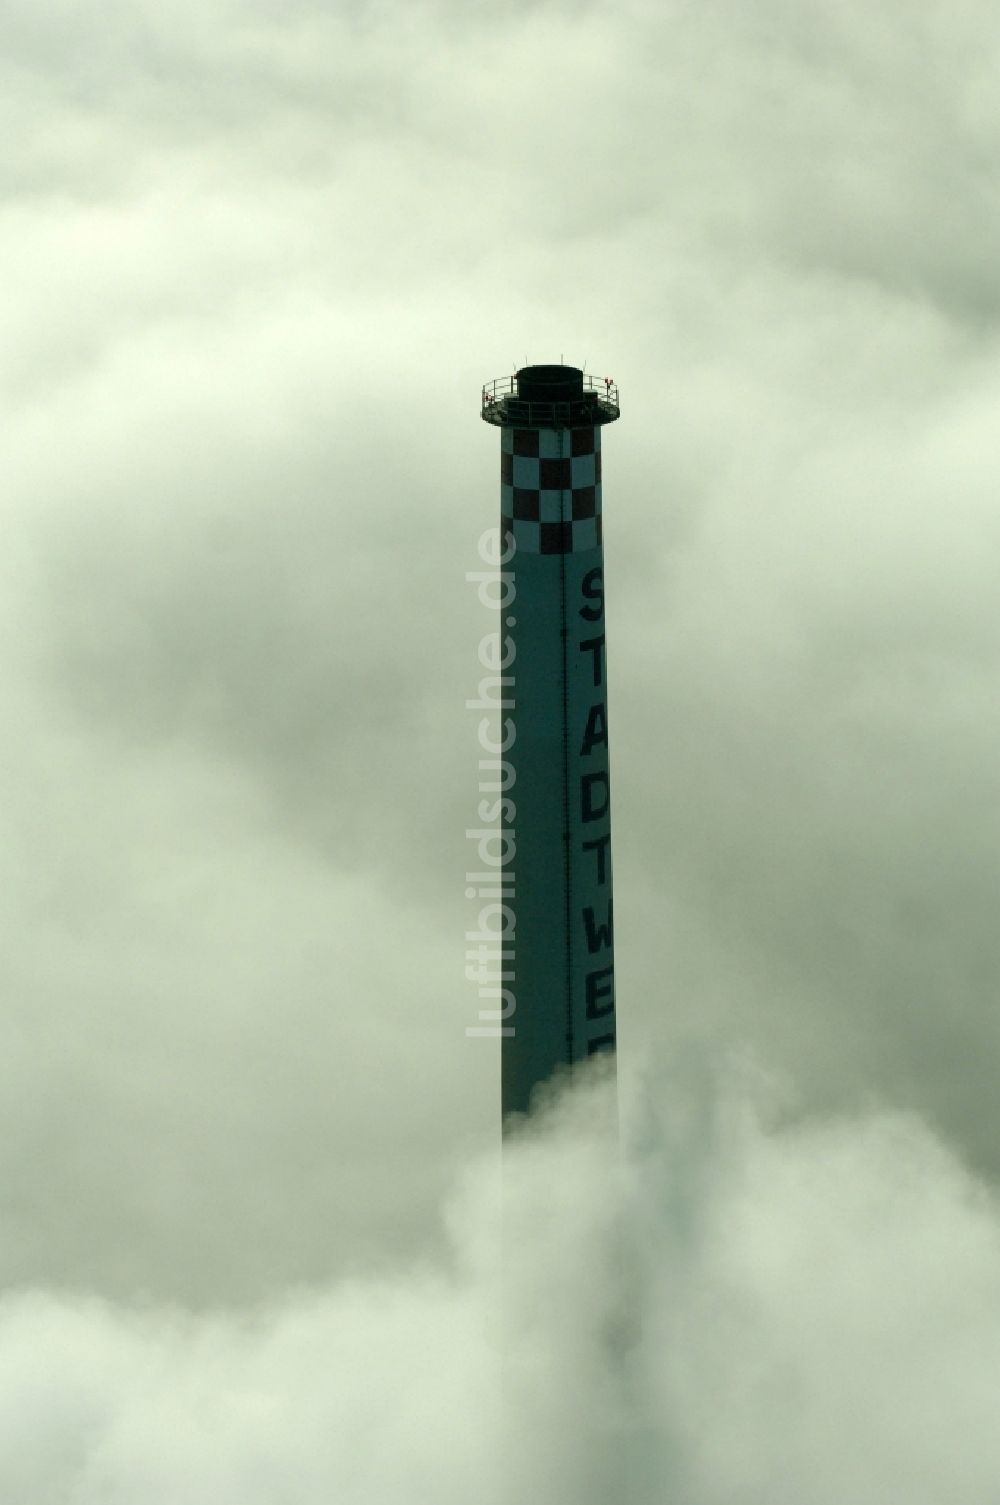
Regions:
[[0, 1060, 1000, 1505]]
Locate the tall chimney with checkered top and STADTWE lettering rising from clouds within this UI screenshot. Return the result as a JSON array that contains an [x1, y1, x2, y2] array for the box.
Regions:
[[482, 366, 619, 1124]]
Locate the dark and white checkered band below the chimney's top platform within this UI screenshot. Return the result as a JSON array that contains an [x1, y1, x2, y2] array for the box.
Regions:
[[500, 427, 601, 554]]
